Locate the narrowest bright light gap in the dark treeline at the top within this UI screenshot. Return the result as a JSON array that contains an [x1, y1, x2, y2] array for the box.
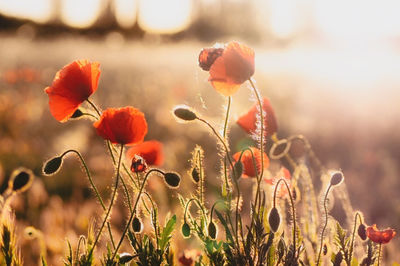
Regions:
[[114, 0, 137, 28]]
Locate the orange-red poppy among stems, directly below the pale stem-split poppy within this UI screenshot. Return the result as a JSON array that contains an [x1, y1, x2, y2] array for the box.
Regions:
[[233, 147, 269, 178]]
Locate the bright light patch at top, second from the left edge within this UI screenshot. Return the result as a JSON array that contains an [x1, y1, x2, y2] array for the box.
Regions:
[[61, 0, 104, 28]]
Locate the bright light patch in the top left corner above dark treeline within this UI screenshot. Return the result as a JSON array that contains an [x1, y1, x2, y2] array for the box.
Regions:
[[0, 0, 53, 23]]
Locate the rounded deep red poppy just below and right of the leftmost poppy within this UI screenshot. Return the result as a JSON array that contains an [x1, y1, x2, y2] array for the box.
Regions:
[[93, 106, 147, 145]]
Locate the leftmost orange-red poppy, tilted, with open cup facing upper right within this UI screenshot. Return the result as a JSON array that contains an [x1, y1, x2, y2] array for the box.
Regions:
[[44, 60, 100, 122]]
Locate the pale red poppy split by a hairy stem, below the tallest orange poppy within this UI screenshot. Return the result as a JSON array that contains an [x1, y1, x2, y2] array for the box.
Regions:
[[236, 98, 278, 136]]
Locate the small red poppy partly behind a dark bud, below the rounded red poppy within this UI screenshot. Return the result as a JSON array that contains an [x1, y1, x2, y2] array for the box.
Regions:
[[126, 140, 164, 166]]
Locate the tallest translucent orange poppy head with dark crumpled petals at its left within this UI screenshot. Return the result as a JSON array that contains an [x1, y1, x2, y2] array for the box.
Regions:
[[199, 42, 254, 96]]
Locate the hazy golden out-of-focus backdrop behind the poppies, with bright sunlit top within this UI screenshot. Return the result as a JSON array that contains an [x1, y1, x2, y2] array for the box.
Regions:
[[0, 0, 400, 264]]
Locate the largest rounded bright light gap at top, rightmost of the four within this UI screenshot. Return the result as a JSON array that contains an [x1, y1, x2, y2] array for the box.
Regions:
[[138, 0, 192, 33]]
